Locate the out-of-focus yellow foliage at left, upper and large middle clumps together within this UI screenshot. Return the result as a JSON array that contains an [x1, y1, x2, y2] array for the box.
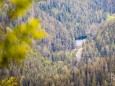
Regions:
[[0, 0, 46, 66]]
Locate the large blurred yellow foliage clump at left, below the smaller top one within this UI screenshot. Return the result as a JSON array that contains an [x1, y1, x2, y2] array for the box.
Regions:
[[0, 19, 46, 65]]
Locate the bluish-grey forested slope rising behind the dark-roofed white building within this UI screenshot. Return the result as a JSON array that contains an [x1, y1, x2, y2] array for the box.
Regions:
[[34, 0, 115, 56]]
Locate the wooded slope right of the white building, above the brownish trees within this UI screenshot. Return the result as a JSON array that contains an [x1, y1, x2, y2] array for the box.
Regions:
[[83, 19, 115, 60]]
